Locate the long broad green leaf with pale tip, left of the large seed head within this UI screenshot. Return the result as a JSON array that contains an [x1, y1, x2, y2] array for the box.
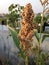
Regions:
[[8, 26, 25, 59]]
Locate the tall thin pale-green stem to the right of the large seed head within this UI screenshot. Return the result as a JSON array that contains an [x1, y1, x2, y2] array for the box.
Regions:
[[36, 6, 44, 65]]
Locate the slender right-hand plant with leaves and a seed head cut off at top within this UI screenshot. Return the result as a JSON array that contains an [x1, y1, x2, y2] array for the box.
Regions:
[[33, 0, 49, 65]]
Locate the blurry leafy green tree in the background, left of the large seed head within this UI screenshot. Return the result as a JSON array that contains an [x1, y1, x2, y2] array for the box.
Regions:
[[5, 4, 24, 28]]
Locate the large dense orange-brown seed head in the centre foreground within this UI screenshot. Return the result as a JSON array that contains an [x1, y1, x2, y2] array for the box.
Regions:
[[18, 3, 37, 55]]
